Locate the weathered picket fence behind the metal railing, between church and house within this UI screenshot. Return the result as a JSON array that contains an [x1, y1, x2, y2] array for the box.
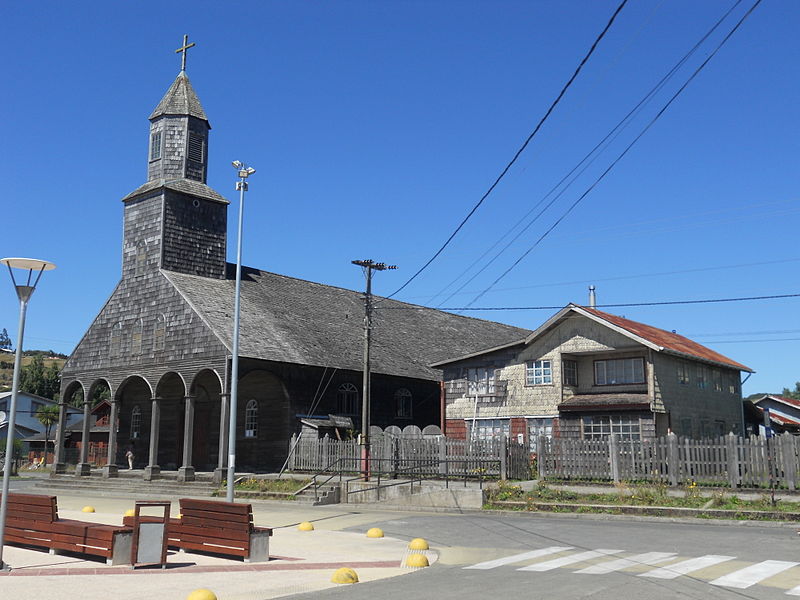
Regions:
[[287, 435, 530, 479]]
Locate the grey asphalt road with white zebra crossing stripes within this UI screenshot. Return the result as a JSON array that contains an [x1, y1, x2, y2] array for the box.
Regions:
[[293, 514, 800, 600]]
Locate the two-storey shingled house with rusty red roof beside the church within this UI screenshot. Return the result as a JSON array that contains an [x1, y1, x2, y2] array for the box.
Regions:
[[432, 304, 752, 444]]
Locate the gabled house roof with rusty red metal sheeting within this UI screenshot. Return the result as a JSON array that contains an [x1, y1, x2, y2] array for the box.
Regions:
[[431, 304, 754, 373]]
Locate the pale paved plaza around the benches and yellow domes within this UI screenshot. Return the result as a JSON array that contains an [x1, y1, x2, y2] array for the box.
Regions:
[[0, 494, 436, 600]]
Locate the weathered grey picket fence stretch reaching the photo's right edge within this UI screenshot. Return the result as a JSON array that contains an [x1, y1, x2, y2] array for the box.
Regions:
[[536, 433, 800, 490]]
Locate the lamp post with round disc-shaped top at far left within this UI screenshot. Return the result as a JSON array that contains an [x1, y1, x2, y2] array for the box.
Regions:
[[0, 258, 56, 571]]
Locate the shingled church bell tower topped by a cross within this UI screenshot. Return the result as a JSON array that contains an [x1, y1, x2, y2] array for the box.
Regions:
[[122, 36, 228, 279]]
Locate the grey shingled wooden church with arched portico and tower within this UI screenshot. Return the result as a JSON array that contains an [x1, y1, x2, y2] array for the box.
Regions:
[[54, 52, 528, 480]]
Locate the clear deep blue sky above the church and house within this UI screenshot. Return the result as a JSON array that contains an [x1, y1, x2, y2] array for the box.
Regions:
[[0, 0, 800, 394]]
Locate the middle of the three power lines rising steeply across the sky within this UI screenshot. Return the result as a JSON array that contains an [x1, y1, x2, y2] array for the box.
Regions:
[[434, 0, 741, 306]]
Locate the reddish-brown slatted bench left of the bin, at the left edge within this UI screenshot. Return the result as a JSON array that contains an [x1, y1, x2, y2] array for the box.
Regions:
[[0, 493, 133, 565]]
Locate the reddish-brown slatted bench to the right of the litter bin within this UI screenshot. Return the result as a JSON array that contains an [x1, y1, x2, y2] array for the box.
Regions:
[[168, 498, 272, 562]]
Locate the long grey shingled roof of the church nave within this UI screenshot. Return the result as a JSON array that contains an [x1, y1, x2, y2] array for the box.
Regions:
[[164, 264, 530, 380]]
